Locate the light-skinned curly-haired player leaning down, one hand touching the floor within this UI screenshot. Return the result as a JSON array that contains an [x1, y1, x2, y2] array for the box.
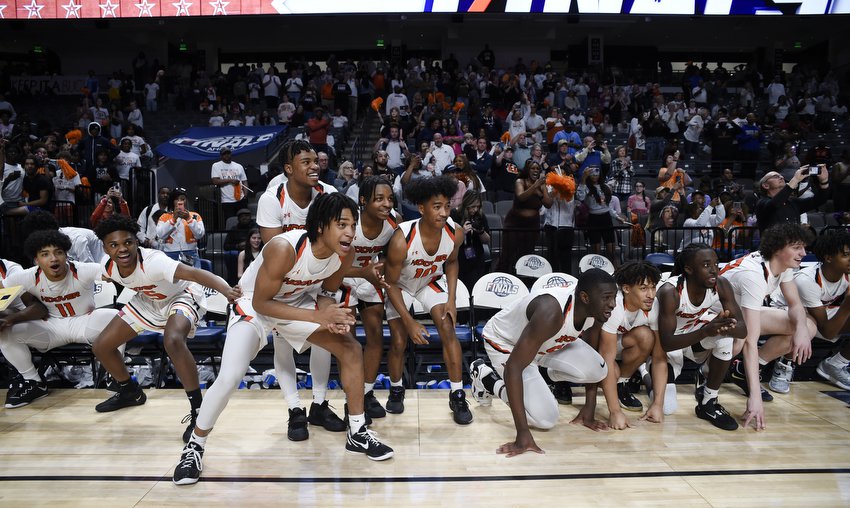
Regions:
[[715, 223, 817, 430]]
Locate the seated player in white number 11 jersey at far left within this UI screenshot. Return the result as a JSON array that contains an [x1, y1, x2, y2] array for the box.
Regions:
[[0, 229, 118, 408]]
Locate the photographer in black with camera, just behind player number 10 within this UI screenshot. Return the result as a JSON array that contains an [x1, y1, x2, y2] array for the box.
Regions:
[[452, 190, 490, 288]]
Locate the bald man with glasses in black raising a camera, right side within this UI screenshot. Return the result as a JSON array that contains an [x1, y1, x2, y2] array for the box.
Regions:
[[756, 164, 829, 231]]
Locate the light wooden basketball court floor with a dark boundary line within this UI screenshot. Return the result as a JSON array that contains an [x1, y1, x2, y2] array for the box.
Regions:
[[0, 382, 850, 508]]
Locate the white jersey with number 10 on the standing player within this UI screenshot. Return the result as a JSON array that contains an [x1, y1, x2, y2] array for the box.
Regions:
[[398, 217, 455, 295]]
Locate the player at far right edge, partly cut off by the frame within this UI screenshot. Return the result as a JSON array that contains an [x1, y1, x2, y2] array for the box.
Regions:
[[759, 230, 850, 393]]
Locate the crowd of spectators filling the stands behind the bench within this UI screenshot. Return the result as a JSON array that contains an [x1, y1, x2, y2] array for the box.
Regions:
[[0, 50, 850, 273]]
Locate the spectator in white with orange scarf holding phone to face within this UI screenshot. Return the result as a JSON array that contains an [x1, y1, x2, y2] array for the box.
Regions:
[[156, 187, 206, 268]]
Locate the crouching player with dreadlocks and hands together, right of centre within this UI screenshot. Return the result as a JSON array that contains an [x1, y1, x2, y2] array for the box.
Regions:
[[656, 243, 744, 430]]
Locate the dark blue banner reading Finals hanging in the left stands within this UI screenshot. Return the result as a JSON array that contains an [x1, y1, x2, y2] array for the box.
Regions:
[[156, 125, 286, 161]]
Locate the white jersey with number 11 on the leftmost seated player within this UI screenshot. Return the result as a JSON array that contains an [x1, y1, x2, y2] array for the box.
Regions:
[[3, 261, 100, 318]]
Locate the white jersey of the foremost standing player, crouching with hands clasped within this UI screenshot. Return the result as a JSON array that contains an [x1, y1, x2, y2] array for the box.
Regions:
[[239, 230, 342, 303]]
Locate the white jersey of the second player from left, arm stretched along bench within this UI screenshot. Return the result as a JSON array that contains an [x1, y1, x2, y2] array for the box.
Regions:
[[102, 247, 206, 302]]
